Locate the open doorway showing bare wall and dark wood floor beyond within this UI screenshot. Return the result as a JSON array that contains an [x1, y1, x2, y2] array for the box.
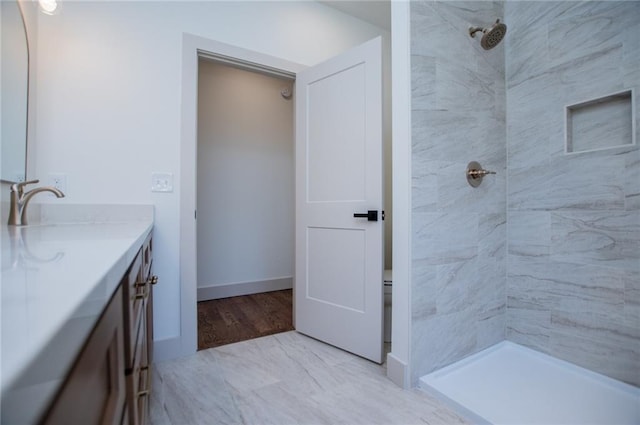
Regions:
[[196, 56, 295, 350]]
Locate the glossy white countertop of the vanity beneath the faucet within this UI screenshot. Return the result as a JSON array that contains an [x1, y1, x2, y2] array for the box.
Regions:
[[0, 210, 153, 423]]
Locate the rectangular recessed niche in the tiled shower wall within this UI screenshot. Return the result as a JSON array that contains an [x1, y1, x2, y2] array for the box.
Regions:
[[565, 90, 635, 154]]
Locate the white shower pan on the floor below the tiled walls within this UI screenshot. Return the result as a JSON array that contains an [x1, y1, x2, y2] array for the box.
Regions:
[[420, 341, 640, 425]]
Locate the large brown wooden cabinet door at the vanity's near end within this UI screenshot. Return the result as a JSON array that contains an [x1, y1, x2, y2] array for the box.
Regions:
[[42, 288, 125, 425]]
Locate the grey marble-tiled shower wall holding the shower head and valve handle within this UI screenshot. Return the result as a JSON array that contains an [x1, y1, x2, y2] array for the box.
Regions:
[[410, 1, 506, 383]]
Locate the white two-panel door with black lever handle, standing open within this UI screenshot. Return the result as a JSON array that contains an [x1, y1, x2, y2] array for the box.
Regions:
[[294, 38, 384, 363]]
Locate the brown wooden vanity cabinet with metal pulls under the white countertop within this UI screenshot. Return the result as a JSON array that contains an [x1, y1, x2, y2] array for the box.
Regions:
[[41, 235, 157, 425]]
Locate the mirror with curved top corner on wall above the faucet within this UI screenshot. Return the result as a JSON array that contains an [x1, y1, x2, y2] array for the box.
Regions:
[[0, 1, 29, 182]]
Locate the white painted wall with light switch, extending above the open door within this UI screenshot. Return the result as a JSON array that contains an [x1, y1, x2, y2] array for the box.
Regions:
[[32, 1, 388, 344]]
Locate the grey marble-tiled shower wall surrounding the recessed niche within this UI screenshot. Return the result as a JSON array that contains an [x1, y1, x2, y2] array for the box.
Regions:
[[505, 1, 640, 385]]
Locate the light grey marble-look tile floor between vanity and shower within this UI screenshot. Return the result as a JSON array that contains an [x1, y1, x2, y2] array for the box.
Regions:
[[151, 331, 468, 425]]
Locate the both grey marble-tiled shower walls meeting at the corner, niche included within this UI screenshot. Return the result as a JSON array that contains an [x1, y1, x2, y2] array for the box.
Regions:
[[410, 1, 640, 386]]
